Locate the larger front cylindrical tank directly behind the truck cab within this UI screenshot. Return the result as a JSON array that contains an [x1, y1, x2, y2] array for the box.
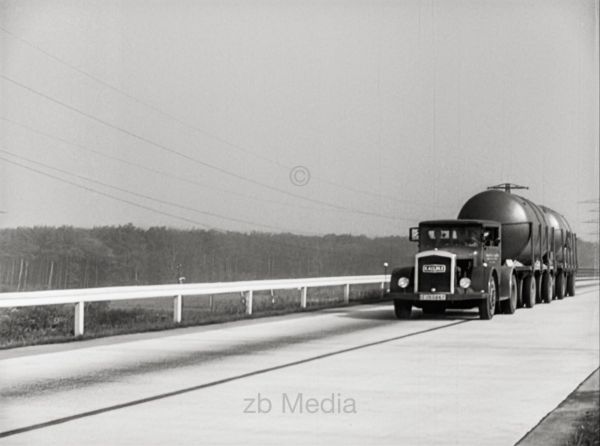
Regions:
[[458, 190, 551, 265]]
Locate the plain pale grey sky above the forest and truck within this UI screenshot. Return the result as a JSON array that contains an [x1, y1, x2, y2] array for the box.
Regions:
[[0, 0, 600, 240]]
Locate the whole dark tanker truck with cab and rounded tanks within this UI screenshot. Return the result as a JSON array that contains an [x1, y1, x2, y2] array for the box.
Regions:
[[388, 184, 577, 319]]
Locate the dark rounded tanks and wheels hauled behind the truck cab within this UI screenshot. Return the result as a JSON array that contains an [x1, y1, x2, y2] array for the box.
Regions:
[[458, 190, 576, 307]]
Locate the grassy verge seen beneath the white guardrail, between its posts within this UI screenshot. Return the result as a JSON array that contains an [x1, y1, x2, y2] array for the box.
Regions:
[[0, 285, 381, 348]]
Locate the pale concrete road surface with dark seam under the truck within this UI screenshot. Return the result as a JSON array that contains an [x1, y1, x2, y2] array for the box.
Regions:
[[0, 285, 600, 445]]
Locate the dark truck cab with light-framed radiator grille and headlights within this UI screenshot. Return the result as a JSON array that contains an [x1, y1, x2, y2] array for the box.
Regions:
[[389, 220, 517, 319]]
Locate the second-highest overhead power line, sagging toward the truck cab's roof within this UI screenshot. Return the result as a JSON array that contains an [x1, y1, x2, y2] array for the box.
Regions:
[[0, 73, 414, 221]]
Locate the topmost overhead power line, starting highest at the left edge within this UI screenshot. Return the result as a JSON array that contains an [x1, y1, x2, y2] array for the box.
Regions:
[[0, 26, 446, 207]]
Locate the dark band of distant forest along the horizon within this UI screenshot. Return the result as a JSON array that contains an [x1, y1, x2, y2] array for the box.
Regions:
[[0, 224, 598, 291]]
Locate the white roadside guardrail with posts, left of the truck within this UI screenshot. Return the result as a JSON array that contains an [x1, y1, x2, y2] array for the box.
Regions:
[[0, 274, 390, 336]]
